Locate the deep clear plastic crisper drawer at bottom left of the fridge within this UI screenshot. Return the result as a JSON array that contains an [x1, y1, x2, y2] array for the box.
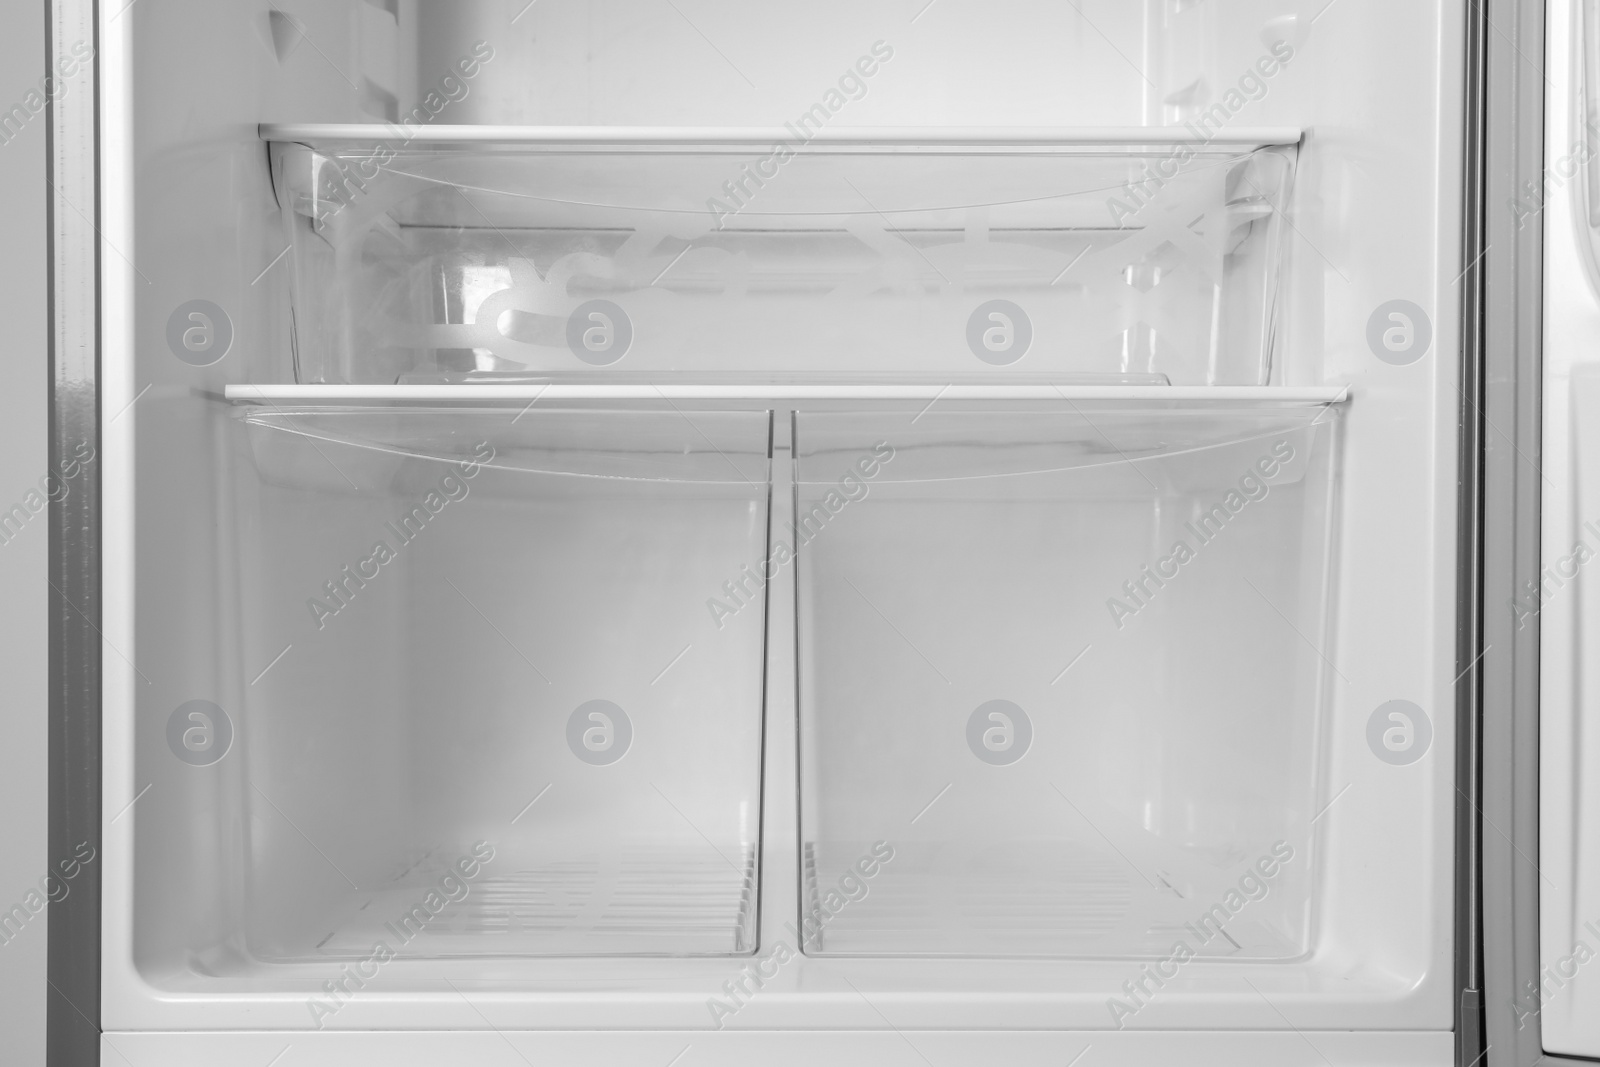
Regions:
[[228, 405, 771, 961]]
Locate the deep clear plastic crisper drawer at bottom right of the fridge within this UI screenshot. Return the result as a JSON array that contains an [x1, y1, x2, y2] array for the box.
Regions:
[[796, 402, 1338, 960]]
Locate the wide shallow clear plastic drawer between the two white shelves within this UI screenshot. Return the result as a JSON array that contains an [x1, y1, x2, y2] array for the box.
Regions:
[[264, 126, 1298, 386]]
